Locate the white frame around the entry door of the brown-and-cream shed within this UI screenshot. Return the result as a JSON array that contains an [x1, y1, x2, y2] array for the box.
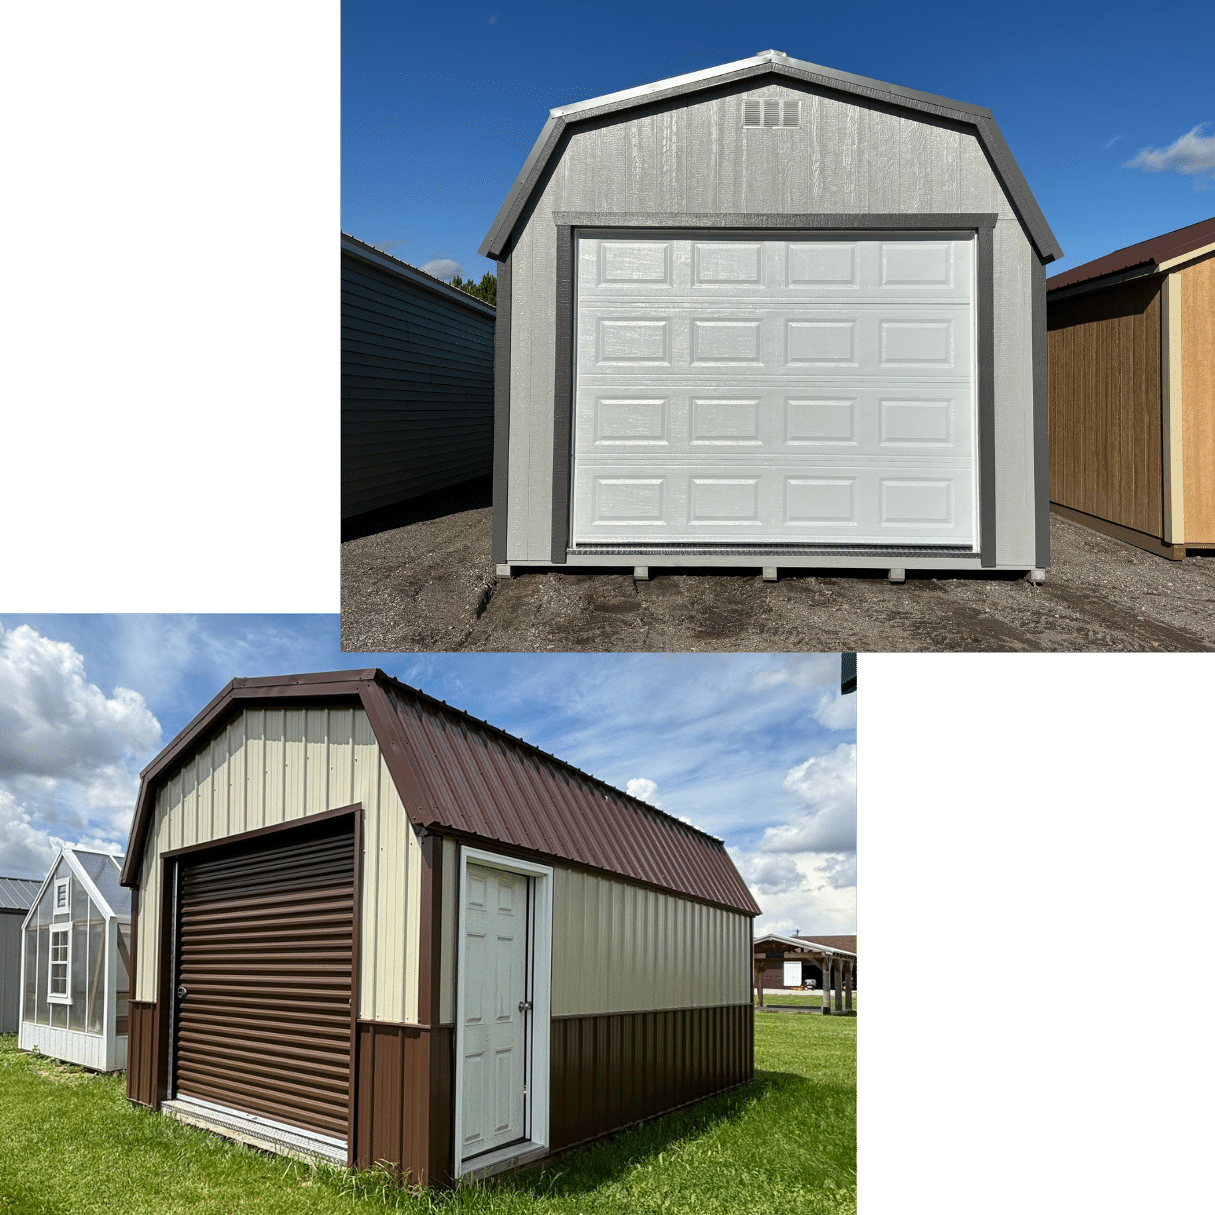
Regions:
[[453, 847, 553, 1177]]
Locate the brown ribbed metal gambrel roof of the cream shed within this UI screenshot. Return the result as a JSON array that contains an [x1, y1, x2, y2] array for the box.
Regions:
[[123, 669, 759, 915]]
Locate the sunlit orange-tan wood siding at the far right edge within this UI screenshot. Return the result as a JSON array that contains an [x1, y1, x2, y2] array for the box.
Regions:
[[1175, 256, 1215, 544]]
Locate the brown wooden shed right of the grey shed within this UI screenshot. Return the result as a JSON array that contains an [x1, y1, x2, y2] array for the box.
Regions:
[[1046, 217, 1215, 560]]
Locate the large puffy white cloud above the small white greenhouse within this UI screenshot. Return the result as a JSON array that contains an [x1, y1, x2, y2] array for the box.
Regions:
[[0, 625, 160, 876]]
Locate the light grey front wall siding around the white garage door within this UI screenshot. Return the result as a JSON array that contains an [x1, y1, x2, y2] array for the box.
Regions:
[[507, 84, 1035, 567]]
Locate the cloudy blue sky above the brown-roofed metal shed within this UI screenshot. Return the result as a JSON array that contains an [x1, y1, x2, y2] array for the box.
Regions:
[[0, 614, 857, 933]]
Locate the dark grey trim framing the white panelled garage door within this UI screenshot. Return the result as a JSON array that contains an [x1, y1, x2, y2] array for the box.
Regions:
[[549, 211, 999, 569]]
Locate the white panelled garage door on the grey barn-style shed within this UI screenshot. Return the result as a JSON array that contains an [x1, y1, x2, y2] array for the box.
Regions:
[[572, 233, 978, 548]]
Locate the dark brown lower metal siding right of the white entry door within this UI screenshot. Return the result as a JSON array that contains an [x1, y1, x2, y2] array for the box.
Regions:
[[549, 1004, 755, 1151]]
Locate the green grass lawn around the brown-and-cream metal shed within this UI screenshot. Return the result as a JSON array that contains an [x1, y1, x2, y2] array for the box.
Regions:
[[0, 1013, 857, 1215]]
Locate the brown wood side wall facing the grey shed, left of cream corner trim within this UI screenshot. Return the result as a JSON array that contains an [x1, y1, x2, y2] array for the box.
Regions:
[[1046, 279, 1164, 537]]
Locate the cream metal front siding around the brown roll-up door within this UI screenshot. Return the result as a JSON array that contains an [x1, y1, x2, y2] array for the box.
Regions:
[[134, 708, 420, 1022]]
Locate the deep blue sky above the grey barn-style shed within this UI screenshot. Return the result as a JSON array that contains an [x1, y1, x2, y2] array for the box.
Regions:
[[341, 0, 1215, 278]]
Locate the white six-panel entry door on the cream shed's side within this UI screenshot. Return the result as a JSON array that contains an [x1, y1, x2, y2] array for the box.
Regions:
[[459, 864, 527, 1160]]
